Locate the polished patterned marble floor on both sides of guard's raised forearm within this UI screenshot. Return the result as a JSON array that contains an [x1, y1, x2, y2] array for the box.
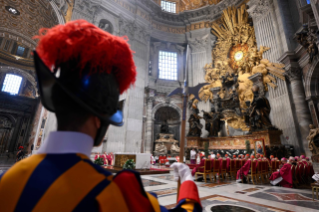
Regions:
[[142, 174, 319, 212]]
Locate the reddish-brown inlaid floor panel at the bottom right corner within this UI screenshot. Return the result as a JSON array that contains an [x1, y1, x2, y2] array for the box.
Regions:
[[249, 188, 319, 209]]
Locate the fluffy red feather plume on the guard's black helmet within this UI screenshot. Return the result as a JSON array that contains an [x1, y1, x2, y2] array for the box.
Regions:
[[34, 20, 136, 94]]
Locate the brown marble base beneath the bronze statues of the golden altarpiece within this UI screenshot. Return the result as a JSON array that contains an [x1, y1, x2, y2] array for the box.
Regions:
[[187, 130, 282, 150]]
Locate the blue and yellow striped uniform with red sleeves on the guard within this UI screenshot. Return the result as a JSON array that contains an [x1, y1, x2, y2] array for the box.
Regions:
[[0, 153, 202, 212]]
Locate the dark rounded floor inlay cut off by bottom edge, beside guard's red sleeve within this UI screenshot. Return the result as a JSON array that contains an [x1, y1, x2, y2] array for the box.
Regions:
[[165, 195, 291, 212]]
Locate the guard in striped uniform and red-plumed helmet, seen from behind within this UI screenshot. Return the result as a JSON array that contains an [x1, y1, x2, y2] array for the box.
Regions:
[[0, 20, 202, 212]]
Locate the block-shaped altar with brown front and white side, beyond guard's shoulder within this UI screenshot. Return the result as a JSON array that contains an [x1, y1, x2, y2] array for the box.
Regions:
[[114, 152, 151, 169]]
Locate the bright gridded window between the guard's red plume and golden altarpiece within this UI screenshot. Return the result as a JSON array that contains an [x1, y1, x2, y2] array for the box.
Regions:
[[158, 51, 177, 80]]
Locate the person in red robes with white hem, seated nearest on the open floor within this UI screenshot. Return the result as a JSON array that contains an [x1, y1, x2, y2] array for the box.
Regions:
[[269, 157, 294, 188]]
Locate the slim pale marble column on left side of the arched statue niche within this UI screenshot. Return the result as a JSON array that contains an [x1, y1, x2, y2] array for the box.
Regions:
[[144, 90, 155, 153]]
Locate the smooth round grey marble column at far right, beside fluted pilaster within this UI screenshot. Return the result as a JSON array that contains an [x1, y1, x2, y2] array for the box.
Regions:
[[286, 66, 312, 156]]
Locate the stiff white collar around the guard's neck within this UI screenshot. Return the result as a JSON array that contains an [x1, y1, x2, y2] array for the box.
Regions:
[[37, 131, 93, 157]]
